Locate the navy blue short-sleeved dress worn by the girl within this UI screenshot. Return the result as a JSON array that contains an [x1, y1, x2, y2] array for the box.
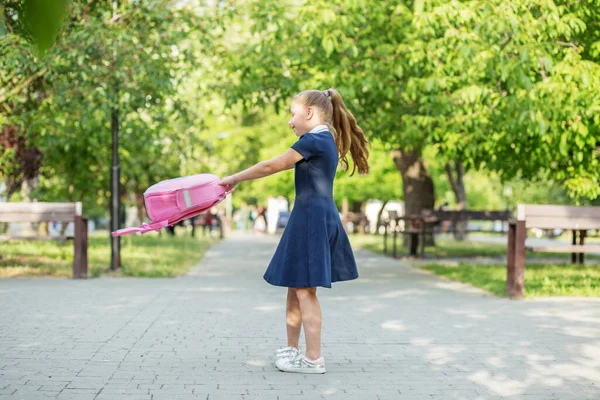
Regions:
[[264, 126, 358, 288]]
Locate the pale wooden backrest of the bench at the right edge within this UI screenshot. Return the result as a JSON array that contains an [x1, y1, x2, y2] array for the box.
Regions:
[[517, 204, 600, 230]]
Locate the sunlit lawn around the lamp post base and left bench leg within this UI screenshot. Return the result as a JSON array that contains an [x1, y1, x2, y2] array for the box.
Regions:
[[0, 232, 218, 278]]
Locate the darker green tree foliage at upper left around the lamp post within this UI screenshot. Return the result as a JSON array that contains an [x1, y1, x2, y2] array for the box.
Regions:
[[0, 0, 220, 215]]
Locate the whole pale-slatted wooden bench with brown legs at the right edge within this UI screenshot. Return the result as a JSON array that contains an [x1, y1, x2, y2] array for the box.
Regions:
[[506, 204, 600, 298]]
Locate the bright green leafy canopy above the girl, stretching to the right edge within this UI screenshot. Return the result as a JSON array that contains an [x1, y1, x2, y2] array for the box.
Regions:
[[213, 0, 600, 198]]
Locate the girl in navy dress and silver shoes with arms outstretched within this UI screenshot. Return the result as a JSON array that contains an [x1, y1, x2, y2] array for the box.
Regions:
[[220, 89, 369, 374]]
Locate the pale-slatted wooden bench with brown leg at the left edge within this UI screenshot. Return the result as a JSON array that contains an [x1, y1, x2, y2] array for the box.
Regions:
[[0, 203, 88, 279]]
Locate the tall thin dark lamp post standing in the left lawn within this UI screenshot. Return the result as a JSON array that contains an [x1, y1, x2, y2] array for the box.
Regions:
[[110, 0, 121, 270]]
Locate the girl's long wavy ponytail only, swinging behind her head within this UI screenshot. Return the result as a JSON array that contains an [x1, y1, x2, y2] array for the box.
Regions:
[[326, 88, 369, 176]]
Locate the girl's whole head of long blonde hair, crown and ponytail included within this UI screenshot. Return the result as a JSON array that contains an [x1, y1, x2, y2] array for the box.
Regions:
[[294, 88, 369, 176]]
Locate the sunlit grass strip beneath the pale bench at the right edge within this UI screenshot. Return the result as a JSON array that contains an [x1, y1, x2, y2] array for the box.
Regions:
[[420, 263, 600, 297]]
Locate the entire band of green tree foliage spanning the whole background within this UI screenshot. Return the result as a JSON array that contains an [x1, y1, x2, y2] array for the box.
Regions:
[[0, 0, 600, 215]]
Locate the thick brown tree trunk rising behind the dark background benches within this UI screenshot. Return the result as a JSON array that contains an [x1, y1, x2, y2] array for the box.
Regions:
[[392, 149, 435, 246]]
